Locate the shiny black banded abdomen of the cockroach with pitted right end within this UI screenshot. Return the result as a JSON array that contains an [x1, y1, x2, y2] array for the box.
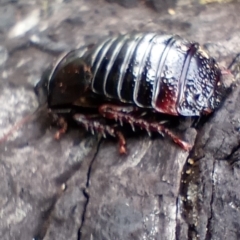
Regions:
[[83, 33, 217, 115]]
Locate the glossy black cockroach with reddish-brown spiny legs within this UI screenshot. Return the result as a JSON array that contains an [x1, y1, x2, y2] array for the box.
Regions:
[[36, 33, 232, 153]]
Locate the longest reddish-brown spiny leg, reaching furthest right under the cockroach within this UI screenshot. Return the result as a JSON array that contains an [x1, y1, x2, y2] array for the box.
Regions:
[[98, 104, 192, 151]]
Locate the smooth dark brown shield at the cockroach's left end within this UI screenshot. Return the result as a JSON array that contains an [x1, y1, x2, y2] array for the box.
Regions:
[[35, 49, 92, 108]]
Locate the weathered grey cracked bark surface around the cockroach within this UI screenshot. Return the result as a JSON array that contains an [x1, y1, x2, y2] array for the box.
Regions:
[[0, 0, 240, 240]]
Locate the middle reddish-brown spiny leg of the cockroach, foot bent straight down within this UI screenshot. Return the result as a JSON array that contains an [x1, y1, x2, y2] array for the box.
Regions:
[[73, 114, 127, 154]]
